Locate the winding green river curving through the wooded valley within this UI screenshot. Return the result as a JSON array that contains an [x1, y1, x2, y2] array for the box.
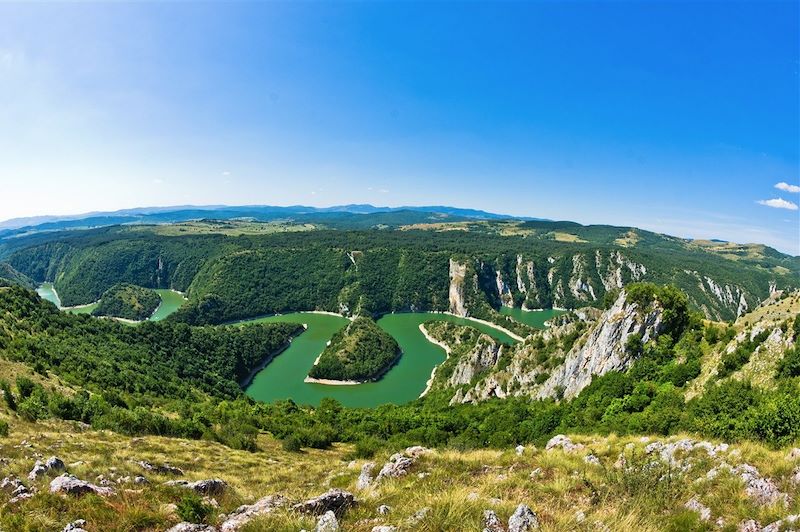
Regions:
[[37, 283, 562, 407]]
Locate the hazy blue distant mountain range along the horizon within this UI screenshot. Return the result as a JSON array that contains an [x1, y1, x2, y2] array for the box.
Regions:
[[0, 204, 544, 238]]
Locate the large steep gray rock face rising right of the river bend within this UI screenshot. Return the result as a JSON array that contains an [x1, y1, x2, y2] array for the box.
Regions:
[[536, 291, 662, 399]]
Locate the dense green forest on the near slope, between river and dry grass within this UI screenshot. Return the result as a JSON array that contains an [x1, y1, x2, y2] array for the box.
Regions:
[[0, 282, 800, 452]]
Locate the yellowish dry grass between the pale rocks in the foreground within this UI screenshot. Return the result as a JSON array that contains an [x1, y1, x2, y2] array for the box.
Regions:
[[0, 416, 800, 532]]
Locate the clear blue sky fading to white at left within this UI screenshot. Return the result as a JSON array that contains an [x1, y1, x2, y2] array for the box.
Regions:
[[0, 1, 800, 254]]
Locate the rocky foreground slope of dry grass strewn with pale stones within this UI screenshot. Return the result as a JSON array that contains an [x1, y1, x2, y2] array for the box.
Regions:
[[0, 423, 800, 532]]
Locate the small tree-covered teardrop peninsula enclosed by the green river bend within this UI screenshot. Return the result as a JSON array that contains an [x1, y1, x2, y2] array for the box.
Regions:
[[308, 316, 400, 382]]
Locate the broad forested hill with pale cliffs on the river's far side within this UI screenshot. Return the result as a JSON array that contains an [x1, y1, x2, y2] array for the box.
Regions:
[[0, 212, 800, 323]]
